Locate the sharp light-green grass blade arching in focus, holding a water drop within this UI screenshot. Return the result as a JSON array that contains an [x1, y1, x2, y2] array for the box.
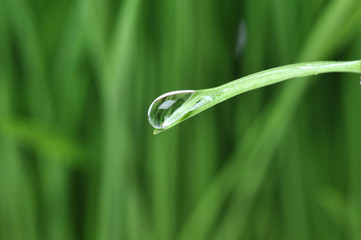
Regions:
[[148, 60, 361, 134]]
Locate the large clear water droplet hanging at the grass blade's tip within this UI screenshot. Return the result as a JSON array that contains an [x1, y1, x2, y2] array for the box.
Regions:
[[148, 90, 194, 129]]
